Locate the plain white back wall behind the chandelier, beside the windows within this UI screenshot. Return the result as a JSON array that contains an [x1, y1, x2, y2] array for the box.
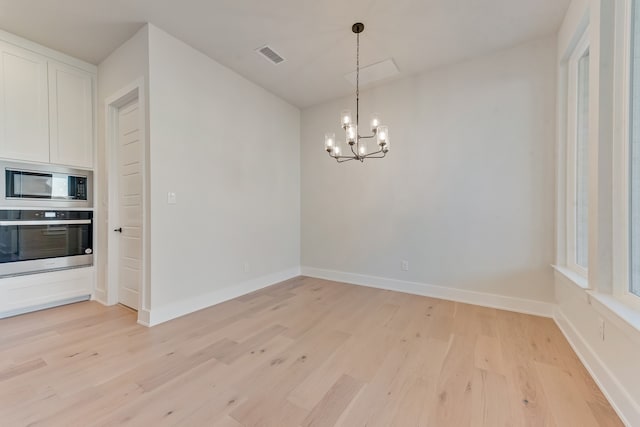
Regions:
[[301, 37, 556, 302]]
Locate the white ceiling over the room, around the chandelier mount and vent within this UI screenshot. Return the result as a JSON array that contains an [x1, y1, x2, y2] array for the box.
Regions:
[[0, 0, 570, 107]]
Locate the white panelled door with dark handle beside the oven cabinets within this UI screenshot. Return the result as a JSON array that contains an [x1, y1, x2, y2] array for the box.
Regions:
[[113, 99, 143, 310]]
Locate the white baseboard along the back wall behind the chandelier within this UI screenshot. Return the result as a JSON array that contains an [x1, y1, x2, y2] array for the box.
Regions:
[[301, 266, 555, 317]]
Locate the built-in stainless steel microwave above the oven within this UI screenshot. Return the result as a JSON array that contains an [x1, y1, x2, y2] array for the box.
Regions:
[[0, 162, 93, 208]]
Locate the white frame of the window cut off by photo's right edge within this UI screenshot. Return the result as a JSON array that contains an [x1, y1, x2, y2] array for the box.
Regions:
[[613, 0, 640, 310]]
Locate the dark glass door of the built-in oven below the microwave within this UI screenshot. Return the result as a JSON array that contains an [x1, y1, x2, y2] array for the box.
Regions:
[[0, 224, 92, 264]]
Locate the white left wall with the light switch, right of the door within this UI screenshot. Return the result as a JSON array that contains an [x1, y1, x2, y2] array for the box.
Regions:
[[149, 26, 300, 323]]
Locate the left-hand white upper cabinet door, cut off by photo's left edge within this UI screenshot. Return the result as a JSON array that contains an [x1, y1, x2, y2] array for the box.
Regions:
[[0, 42, 49, 162]]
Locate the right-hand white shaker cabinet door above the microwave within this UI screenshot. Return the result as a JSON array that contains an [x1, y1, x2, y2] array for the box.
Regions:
[[49, 61, 93, 168]]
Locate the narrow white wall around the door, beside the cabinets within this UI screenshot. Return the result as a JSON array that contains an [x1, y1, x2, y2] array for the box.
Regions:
[[95, 25, 149, 302]]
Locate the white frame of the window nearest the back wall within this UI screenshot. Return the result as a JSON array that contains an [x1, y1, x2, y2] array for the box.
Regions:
[[564, 26, 591, 280]]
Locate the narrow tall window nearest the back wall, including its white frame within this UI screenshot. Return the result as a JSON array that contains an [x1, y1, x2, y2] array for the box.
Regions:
[[566, 31, 589, 277]]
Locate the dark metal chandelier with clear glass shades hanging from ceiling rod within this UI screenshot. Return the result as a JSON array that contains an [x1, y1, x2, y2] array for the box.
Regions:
[[324, 22, 389, 163]]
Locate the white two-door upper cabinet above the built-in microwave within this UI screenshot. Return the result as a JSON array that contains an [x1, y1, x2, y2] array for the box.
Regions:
[[0, 30, 96, 169]]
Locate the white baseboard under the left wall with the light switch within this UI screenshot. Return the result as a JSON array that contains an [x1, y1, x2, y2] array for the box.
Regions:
[[145, 267, 300, 326]]
